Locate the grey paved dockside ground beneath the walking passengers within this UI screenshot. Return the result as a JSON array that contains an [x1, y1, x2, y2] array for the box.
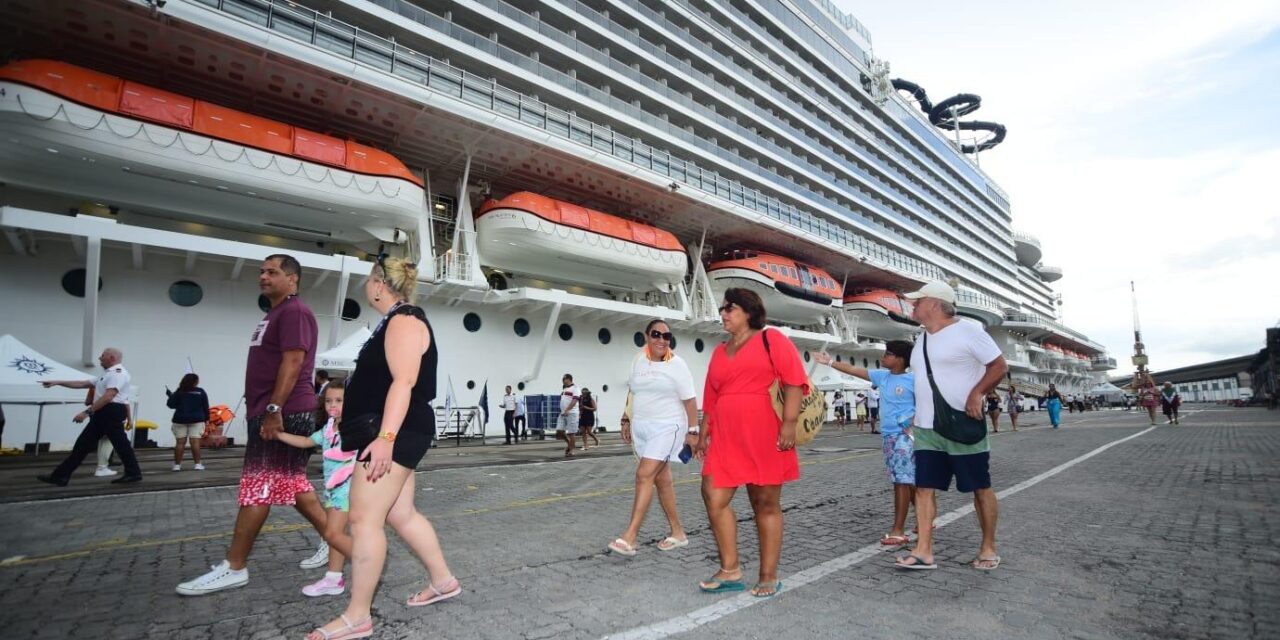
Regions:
[[0, 406, 1280, 639]]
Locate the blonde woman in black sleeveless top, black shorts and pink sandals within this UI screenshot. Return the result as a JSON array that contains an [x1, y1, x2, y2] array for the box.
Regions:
[[307, 256, 462, 640]]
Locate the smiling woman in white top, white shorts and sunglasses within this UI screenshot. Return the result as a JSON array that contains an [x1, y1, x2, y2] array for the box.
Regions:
[[609, 320, 698, 556]]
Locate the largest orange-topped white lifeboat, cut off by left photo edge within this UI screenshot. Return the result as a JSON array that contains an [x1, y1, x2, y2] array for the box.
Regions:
[[0, 60, 425, 242]]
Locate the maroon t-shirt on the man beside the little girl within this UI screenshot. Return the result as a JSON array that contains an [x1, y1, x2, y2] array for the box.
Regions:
[[244, 296, 319, 417]]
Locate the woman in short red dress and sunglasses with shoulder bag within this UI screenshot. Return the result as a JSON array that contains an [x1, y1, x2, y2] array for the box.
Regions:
[[695, 288, 808, 598]]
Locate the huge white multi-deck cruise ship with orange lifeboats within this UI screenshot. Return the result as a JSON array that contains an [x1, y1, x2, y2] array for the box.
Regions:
[[0, 0, 1115, 448]]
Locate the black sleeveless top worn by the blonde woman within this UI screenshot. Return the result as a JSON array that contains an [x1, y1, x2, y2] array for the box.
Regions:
[[342, 305, 439, 433]]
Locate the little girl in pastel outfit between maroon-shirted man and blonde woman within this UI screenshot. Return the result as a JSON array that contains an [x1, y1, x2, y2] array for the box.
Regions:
[[276, 380, 356, 598]]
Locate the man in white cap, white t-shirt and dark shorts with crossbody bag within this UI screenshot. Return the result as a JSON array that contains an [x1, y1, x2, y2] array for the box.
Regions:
[[896, 280, 1009, 571]]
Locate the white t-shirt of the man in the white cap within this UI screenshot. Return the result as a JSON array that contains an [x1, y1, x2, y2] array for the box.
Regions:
[[911, 321, 1002, 429]]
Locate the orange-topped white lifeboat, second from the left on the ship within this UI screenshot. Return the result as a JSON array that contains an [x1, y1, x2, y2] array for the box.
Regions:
[[476, 191, 689, 292]]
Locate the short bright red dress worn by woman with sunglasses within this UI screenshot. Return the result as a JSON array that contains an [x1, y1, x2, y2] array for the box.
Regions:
[[703, 329, 809, 489]]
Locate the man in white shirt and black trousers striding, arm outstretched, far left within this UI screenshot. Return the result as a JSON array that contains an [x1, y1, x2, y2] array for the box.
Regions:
[[36, 347, 142, 486]]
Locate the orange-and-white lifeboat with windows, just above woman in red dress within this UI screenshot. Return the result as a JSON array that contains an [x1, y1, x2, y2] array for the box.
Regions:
[[707, 250, 842, 325]]
